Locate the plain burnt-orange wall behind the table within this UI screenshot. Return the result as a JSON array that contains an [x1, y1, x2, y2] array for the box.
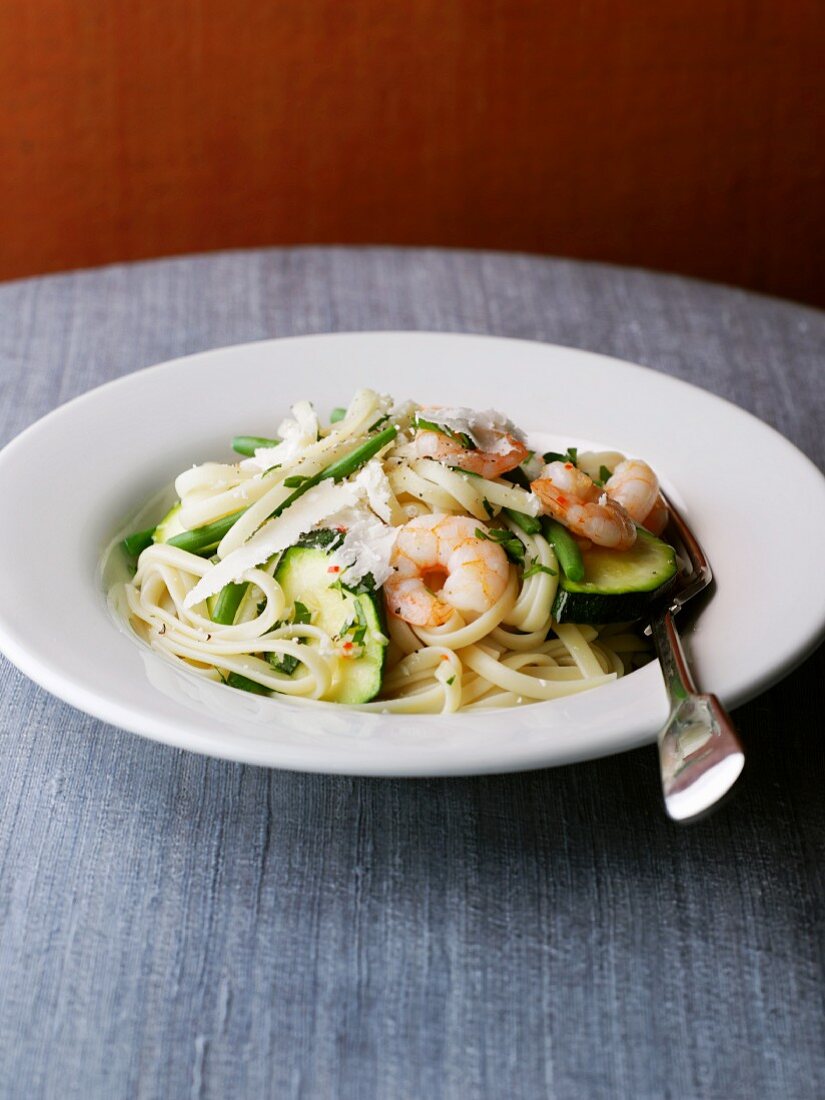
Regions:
[[0, 0, 825, 303]]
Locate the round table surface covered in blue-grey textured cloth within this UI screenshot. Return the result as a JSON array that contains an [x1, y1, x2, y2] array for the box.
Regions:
[[0, 249, 825, 1100]]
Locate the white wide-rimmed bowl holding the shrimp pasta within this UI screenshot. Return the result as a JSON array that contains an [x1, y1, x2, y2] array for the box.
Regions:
[[0, 332, 825, 776]]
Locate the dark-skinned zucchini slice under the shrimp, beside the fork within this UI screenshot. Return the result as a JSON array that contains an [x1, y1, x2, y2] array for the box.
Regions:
[[552, 528, 678, 624]]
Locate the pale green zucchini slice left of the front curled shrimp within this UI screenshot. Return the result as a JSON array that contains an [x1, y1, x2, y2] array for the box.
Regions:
[[275, 541, 387, 704]]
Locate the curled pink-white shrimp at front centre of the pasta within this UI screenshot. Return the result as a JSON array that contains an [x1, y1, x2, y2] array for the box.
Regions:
[[384, 514, 509, 627]]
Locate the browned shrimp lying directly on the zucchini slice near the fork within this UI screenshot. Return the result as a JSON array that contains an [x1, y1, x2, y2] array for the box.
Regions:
[[530, 462, 636, 550]]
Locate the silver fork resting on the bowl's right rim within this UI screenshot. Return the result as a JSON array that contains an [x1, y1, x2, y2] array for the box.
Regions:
[[648, 501, 745, 822]]
